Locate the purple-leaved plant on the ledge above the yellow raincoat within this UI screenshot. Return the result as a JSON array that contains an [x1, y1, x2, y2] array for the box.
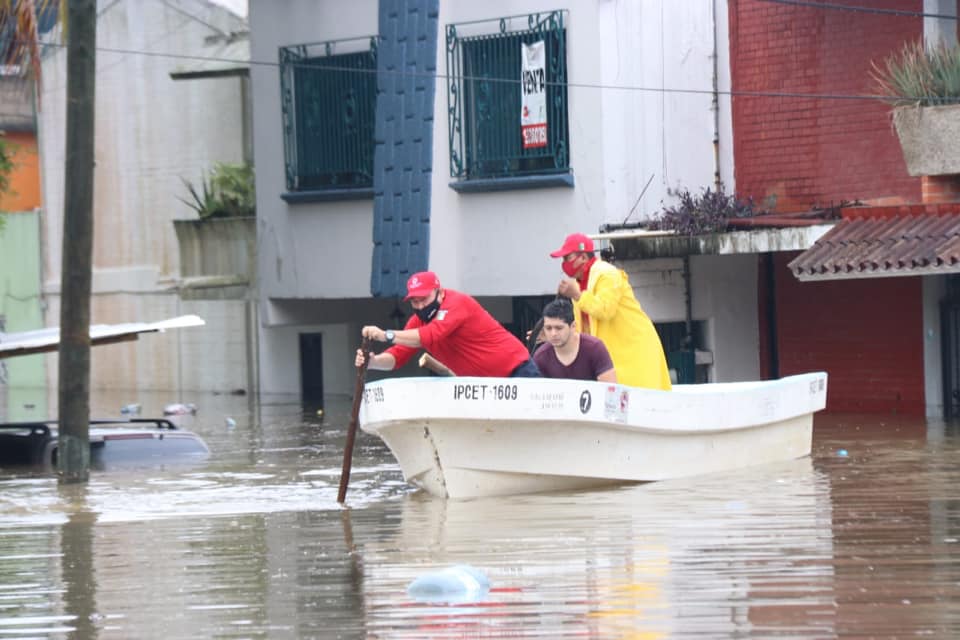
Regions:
[[647, 184, 765, 236]]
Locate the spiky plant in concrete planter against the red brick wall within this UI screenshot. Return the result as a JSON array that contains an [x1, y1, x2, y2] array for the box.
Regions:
[[873, 42, 960, 176]]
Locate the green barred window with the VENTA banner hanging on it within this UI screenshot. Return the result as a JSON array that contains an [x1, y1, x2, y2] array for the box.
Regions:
[[446, 11, 570, 180]]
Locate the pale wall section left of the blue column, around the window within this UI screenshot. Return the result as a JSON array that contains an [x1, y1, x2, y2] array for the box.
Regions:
[[250, 0, 380, 304]]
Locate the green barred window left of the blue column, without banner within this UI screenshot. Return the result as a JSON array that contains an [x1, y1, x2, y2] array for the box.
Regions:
[[280, 37, 377, 191]]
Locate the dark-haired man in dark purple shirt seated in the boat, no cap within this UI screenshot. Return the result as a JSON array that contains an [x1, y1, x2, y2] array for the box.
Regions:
[[533, 298, 617, 382]]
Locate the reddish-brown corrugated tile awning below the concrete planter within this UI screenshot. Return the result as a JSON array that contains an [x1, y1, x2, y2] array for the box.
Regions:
[[788, 214, 960, 280]]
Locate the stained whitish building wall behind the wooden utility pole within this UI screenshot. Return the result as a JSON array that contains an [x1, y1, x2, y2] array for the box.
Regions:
[[39, 0, 247, 390]]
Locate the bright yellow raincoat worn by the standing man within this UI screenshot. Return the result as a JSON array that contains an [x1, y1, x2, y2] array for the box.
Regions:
[[573, 259, 670, 390]]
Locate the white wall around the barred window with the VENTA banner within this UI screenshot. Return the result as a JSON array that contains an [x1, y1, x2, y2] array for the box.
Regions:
[[430, 0, 733, 295]]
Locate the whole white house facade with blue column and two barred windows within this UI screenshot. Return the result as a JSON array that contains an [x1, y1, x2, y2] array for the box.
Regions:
[[250, 0, 740, 396]]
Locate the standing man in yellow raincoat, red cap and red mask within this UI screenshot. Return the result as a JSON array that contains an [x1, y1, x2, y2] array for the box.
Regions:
[[550, 233, 670, 390]]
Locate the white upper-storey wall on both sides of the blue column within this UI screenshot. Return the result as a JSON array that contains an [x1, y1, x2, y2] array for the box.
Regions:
[[250, 0, 732, 300]]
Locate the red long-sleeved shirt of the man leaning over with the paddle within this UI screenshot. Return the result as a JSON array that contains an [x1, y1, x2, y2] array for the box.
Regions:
[[385, 289, 530, 378]]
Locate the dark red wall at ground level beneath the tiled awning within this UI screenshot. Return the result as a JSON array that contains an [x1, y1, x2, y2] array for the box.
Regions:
[[760, 253, 925, 416]]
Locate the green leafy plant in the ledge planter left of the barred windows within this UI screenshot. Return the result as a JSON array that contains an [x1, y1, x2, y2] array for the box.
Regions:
[[180, 162, 257, 220]]
